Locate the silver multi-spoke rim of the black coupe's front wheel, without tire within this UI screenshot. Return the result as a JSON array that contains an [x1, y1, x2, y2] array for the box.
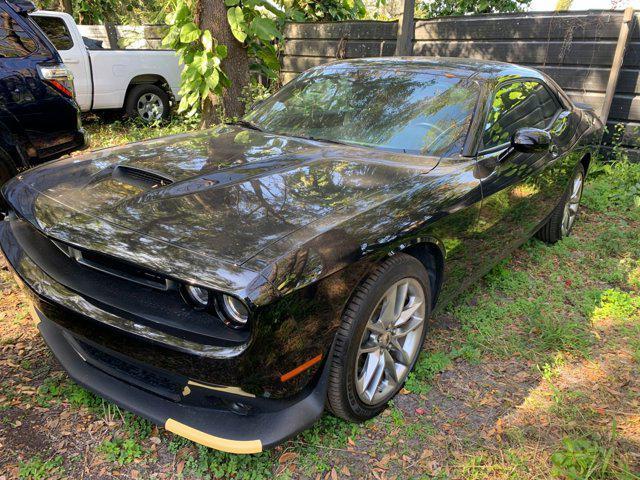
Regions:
[[355, 278, 425, 405]]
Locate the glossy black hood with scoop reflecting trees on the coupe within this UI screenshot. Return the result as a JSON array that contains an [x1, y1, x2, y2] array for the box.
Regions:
[[5, 126, 437, 265]]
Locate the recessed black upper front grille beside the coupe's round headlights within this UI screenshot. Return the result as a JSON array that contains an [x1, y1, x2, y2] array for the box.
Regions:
[[11, 220, 249, 347]]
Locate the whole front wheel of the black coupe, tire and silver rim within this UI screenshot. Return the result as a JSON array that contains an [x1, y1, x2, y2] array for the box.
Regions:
[[327, 253, 431, 421]]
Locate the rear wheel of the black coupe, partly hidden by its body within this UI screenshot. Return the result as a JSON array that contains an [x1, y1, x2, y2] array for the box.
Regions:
[[536, 163, 585, 243]]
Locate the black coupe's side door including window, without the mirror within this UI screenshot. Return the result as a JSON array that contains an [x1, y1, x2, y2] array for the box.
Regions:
[[476, 78, 577, 260]]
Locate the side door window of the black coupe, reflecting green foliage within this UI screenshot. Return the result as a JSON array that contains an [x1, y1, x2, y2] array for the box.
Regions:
[[482, 81, 560, 149]]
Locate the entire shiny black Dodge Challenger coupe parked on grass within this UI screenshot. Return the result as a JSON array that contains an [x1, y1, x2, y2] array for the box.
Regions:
[[0, 58, 602, 453]]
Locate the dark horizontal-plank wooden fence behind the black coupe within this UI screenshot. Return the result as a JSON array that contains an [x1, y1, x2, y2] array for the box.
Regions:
[[282, 11, 640, 157]]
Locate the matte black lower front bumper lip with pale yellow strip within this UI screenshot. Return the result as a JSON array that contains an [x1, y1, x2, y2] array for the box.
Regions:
[[34, 307, 328, 453]]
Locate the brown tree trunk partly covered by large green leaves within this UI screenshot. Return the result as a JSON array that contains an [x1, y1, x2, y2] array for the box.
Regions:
[[195, 0, 249, 126]]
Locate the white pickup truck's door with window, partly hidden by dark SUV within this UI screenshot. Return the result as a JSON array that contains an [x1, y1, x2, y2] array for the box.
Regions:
[[31, 14, 93, 111]]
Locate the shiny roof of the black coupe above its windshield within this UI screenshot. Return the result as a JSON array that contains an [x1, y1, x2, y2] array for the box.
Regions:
[[318, 57, 546, 80]]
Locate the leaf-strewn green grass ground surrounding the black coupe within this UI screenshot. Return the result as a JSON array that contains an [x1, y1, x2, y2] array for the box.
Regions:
[[0, 118, 640, 480]]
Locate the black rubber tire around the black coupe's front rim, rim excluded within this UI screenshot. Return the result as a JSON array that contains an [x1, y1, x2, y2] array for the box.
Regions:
[[327, 253, 432, 422]]
